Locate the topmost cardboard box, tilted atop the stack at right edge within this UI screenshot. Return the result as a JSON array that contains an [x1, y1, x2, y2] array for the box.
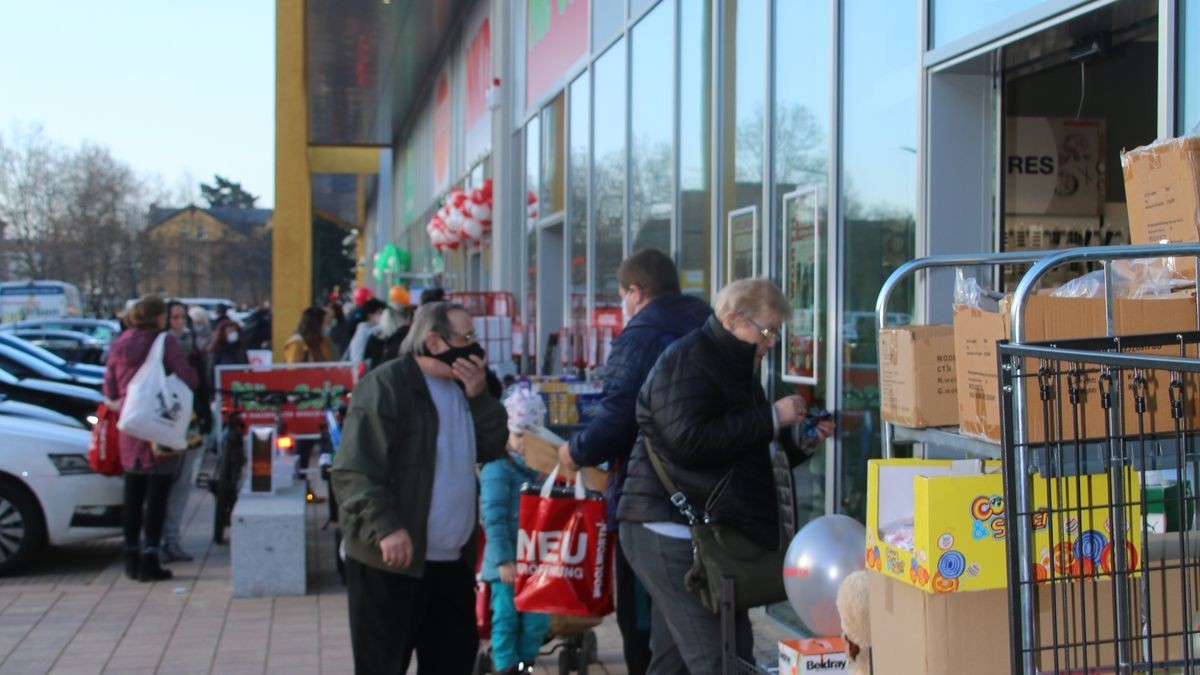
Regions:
[[1121, 136, 1200, 277]]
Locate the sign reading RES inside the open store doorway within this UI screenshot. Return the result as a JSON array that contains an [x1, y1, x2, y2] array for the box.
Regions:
[[1004, 117, 1104, 216]]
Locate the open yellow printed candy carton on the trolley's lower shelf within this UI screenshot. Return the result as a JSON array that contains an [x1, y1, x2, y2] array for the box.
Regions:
[[866, 460, 1141, 593]]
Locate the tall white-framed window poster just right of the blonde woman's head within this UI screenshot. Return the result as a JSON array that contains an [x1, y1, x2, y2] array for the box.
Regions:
[[782, 187, 822, 386]]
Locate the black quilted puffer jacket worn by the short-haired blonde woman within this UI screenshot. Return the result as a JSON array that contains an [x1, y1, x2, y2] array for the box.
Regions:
[[618, 317, 811, 546]]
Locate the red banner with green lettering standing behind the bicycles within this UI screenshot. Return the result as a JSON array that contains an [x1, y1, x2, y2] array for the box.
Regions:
[[216, 363, 358, 437]]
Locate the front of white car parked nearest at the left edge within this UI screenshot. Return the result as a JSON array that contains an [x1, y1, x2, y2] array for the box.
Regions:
[[0, 413, 124, 575]]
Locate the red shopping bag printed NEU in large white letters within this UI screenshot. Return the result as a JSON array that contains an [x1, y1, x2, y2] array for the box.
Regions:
[[514, 466, 613, 616]]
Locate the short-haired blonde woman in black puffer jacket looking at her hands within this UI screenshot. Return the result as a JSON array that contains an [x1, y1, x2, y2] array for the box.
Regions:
[[617, 279, 833, 675]]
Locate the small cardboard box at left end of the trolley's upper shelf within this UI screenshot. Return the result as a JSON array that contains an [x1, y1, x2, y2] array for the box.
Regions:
[[880, 324, 959, 429]]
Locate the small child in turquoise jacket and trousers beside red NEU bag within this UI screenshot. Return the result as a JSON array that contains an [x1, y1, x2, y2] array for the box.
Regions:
[[479, 442, 550, 674]]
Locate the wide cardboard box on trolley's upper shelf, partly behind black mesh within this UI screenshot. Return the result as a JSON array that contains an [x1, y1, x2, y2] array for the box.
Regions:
[[954, 294, 1198, 443]]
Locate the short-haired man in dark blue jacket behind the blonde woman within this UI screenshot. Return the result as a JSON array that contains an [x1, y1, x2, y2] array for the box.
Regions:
[[558, 249, 713, 675]]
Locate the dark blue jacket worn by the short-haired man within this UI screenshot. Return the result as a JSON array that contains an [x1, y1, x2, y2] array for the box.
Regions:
[[571, 293, 713, 514]]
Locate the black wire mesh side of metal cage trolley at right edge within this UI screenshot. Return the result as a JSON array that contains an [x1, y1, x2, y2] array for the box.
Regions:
[[998, 331, 1200, 674]]
